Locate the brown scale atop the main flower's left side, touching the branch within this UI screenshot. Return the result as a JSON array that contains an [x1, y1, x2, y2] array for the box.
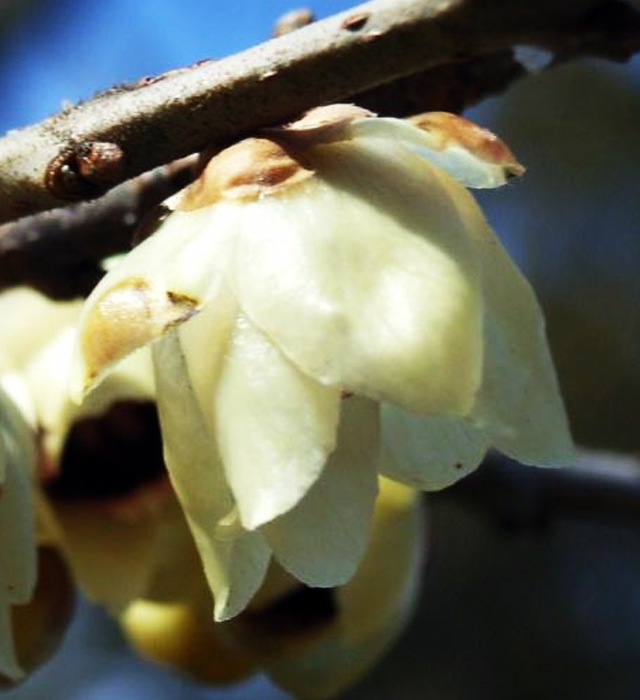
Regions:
[[175, 138, 313, 211]]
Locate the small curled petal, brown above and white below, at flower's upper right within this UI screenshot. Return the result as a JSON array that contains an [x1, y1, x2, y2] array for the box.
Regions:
[[350, 117, 524, 188]]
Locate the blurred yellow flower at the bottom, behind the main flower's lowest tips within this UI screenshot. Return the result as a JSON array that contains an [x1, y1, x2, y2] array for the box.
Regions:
[[120, 479, 427, 698]]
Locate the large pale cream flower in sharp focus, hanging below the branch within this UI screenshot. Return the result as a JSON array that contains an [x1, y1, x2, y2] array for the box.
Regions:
[[73, 105, 572, 619]]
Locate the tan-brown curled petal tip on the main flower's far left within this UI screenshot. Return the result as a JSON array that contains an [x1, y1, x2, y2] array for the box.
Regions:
[[80, 278, 199, 383]]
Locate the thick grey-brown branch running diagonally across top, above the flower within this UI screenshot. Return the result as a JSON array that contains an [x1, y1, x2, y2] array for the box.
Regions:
[[0, 0, 640, 221]]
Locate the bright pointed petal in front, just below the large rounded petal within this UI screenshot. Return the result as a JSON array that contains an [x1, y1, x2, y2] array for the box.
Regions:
[[214, 315, 340, 530]]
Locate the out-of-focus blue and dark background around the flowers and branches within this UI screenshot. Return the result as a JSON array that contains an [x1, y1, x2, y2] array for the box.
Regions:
[[0, 0, 640, 700]]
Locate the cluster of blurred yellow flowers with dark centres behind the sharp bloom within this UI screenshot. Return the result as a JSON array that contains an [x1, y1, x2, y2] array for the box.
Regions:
[[0, 290, 426, 698]]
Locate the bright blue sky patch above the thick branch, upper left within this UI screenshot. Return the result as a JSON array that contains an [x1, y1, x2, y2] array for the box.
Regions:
[[0, 0, 354, 131]]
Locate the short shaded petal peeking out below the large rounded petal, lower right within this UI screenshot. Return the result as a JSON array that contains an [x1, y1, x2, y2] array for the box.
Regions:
[[382, 406, 488, 491]]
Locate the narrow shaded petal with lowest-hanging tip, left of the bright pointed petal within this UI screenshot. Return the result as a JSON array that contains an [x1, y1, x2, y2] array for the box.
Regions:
[[153, 331, 270, 620]]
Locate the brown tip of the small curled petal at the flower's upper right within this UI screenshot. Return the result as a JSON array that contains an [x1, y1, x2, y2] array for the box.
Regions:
[[408, 112, 525, 180]]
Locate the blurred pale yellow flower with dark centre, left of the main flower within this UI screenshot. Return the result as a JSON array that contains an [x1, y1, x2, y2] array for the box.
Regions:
[[0, 289, 162, 611]]
